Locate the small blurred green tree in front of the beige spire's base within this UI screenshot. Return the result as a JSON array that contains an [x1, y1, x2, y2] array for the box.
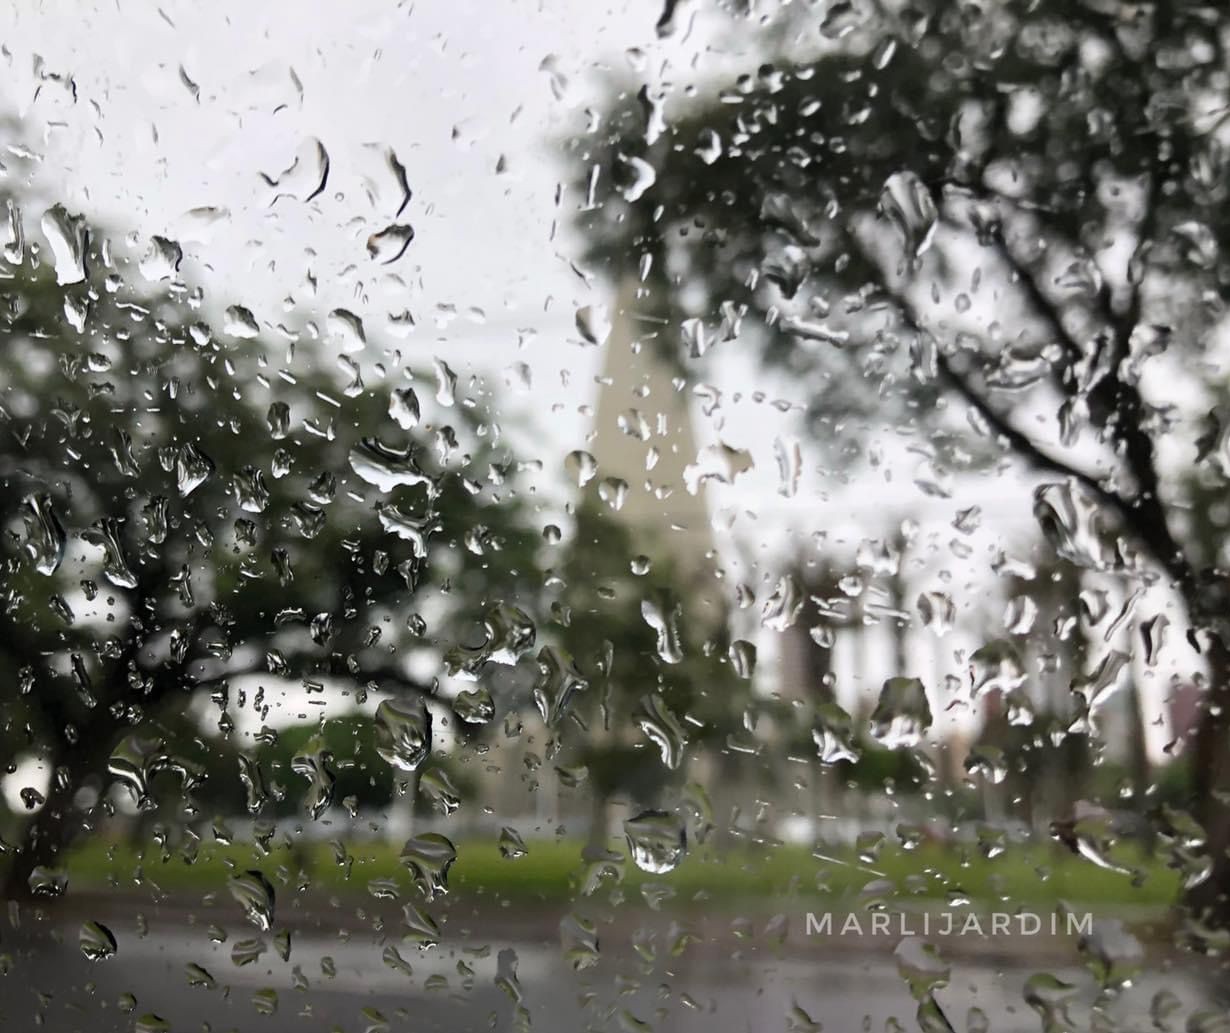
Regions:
[[555, 497, 750, 846]]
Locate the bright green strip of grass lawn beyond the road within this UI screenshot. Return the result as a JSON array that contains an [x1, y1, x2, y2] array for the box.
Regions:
[[57, 840, 1178, 909]]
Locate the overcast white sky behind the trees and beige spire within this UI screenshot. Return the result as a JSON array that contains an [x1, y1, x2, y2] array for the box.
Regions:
[[0, 0, 1190, 782]]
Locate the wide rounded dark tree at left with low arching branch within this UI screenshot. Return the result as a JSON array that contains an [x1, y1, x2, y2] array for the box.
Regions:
[[0, 199, 540, 896]]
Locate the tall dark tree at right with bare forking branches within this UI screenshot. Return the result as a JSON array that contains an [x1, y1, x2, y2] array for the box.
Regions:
[[571, 0, 1230, 922]]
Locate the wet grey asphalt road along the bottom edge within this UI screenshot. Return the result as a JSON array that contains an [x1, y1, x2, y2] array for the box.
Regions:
[[0, 914, 1214, 1033]]
